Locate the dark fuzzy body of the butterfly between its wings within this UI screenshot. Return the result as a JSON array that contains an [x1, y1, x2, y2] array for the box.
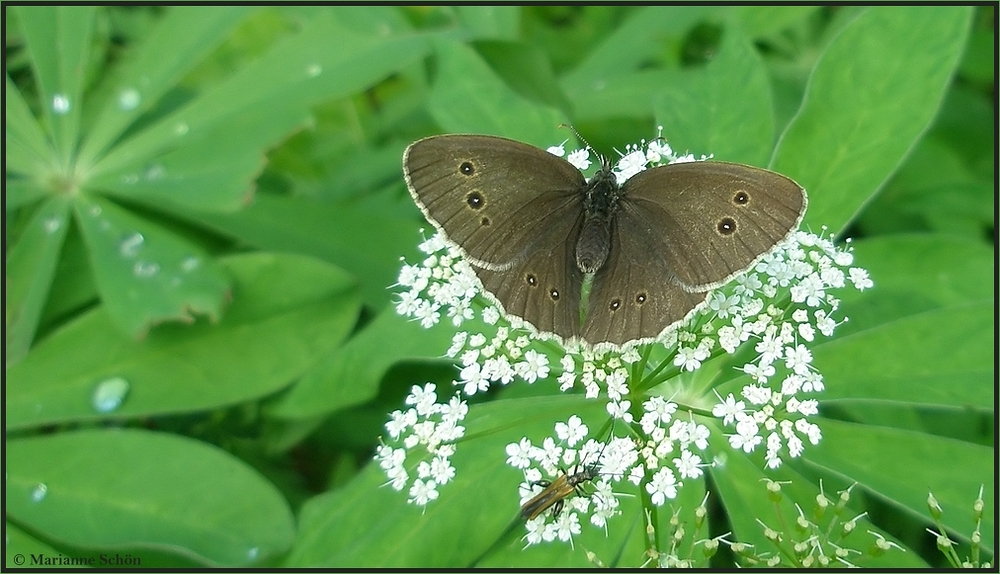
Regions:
[[576, 162, 621, 273]]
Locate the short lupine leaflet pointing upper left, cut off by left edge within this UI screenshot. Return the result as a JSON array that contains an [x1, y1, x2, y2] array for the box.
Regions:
[[3, 74, 57, 178]]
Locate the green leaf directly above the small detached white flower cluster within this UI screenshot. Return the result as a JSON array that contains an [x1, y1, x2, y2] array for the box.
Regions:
[[267, 307, 458, 419]]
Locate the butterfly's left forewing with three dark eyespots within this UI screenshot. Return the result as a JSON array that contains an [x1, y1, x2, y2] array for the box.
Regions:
[[403, 135, 584, 270]]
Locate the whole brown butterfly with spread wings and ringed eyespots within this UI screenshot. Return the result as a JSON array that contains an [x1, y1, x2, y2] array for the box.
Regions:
[[403, 135, 806, 346]]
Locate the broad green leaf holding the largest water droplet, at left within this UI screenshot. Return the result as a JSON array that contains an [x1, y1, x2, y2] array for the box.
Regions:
[[5, 253, 359, 430]]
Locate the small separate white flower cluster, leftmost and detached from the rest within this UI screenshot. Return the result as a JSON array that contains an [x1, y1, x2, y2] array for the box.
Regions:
[[375, 383, 469, 506]]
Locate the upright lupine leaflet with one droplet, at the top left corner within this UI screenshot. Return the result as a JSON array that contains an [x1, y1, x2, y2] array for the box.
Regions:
[[17, 6, 97, 168]]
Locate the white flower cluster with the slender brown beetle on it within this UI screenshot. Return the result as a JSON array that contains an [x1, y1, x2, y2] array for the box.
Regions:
[[507, 408, 709, 545]]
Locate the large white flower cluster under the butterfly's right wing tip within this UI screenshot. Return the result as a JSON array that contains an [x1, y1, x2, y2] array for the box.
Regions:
[[692, 231, 872, 468]]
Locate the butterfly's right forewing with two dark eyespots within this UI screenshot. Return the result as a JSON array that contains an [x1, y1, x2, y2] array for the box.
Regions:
[[619, 161, 806, 291]]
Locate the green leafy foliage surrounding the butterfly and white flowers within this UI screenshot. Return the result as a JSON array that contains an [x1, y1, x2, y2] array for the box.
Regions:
[[4, 6, 996, 568]]
